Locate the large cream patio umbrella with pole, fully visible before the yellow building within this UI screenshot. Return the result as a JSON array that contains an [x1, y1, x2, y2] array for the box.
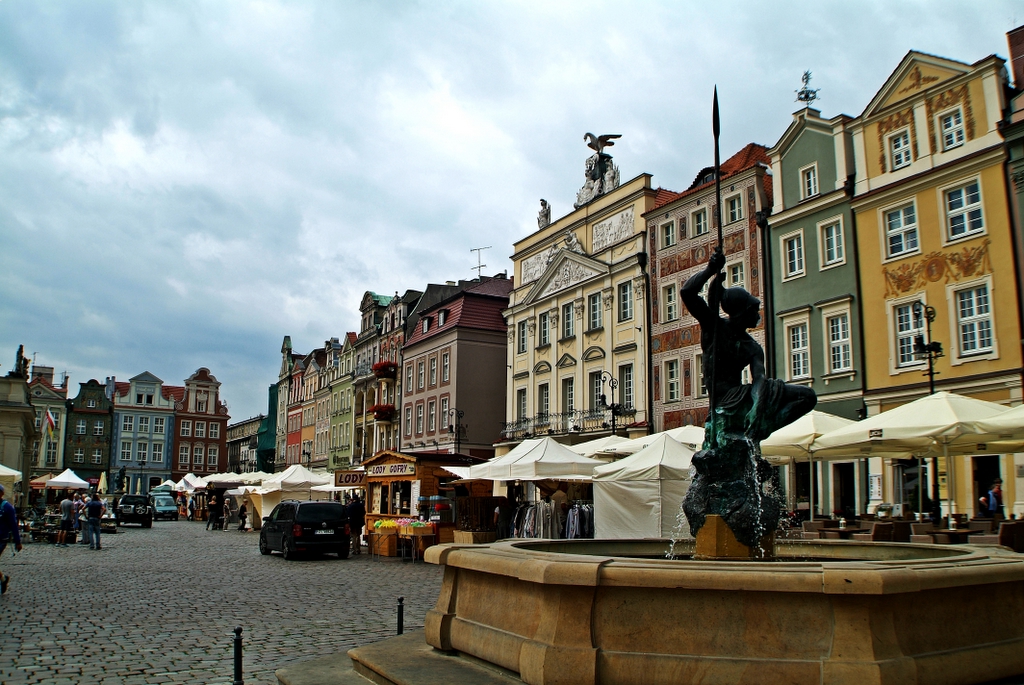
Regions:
[[813, 392, 1007, 514]]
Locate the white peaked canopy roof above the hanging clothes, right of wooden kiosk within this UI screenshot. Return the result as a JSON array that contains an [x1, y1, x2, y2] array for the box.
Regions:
[[469, 437, 604, 480]]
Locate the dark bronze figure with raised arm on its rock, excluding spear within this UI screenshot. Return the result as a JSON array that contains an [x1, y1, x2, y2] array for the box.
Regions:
[[681, 246, 817, 548]]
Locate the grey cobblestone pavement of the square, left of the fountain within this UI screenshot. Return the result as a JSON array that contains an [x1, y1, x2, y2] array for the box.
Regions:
[[0, 521, 442, 685]]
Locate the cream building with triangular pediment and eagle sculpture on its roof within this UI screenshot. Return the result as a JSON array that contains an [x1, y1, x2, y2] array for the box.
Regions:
[[496, 153, 656, 456]]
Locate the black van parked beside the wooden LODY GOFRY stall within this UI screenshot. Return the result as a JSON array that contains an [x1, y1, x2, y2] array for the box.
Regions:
[[259, 500, 352, 559]]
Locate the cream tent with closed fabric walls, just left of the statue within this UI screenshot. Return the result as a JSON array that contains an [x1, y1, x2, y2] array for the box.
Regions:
[[594, 433, 694, 539]]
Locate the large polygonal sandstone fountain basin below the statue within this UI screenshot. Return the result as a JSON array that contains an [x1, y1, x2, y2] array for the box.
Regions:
[[425, 540, 1024, 685]]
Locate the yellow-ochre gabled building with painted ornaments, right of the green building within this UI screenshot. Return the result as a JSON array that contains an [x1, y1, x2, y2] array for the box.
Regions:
[[850, 52, 1024, 514]]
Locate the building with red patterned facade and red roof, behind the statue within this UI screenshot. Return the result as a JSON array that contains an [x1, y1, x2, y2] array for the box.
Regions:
[[644, 143, 772, 431]]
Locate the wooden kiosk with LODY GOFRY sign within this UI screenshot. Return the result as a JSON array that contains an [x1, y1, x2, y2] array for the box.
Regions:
[[362, 451, 489, 556]]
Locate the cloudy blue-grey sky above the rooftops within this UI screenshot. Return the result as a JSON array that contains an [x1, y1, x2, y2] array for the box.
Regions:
[[0, 0, 1024, 419]]
